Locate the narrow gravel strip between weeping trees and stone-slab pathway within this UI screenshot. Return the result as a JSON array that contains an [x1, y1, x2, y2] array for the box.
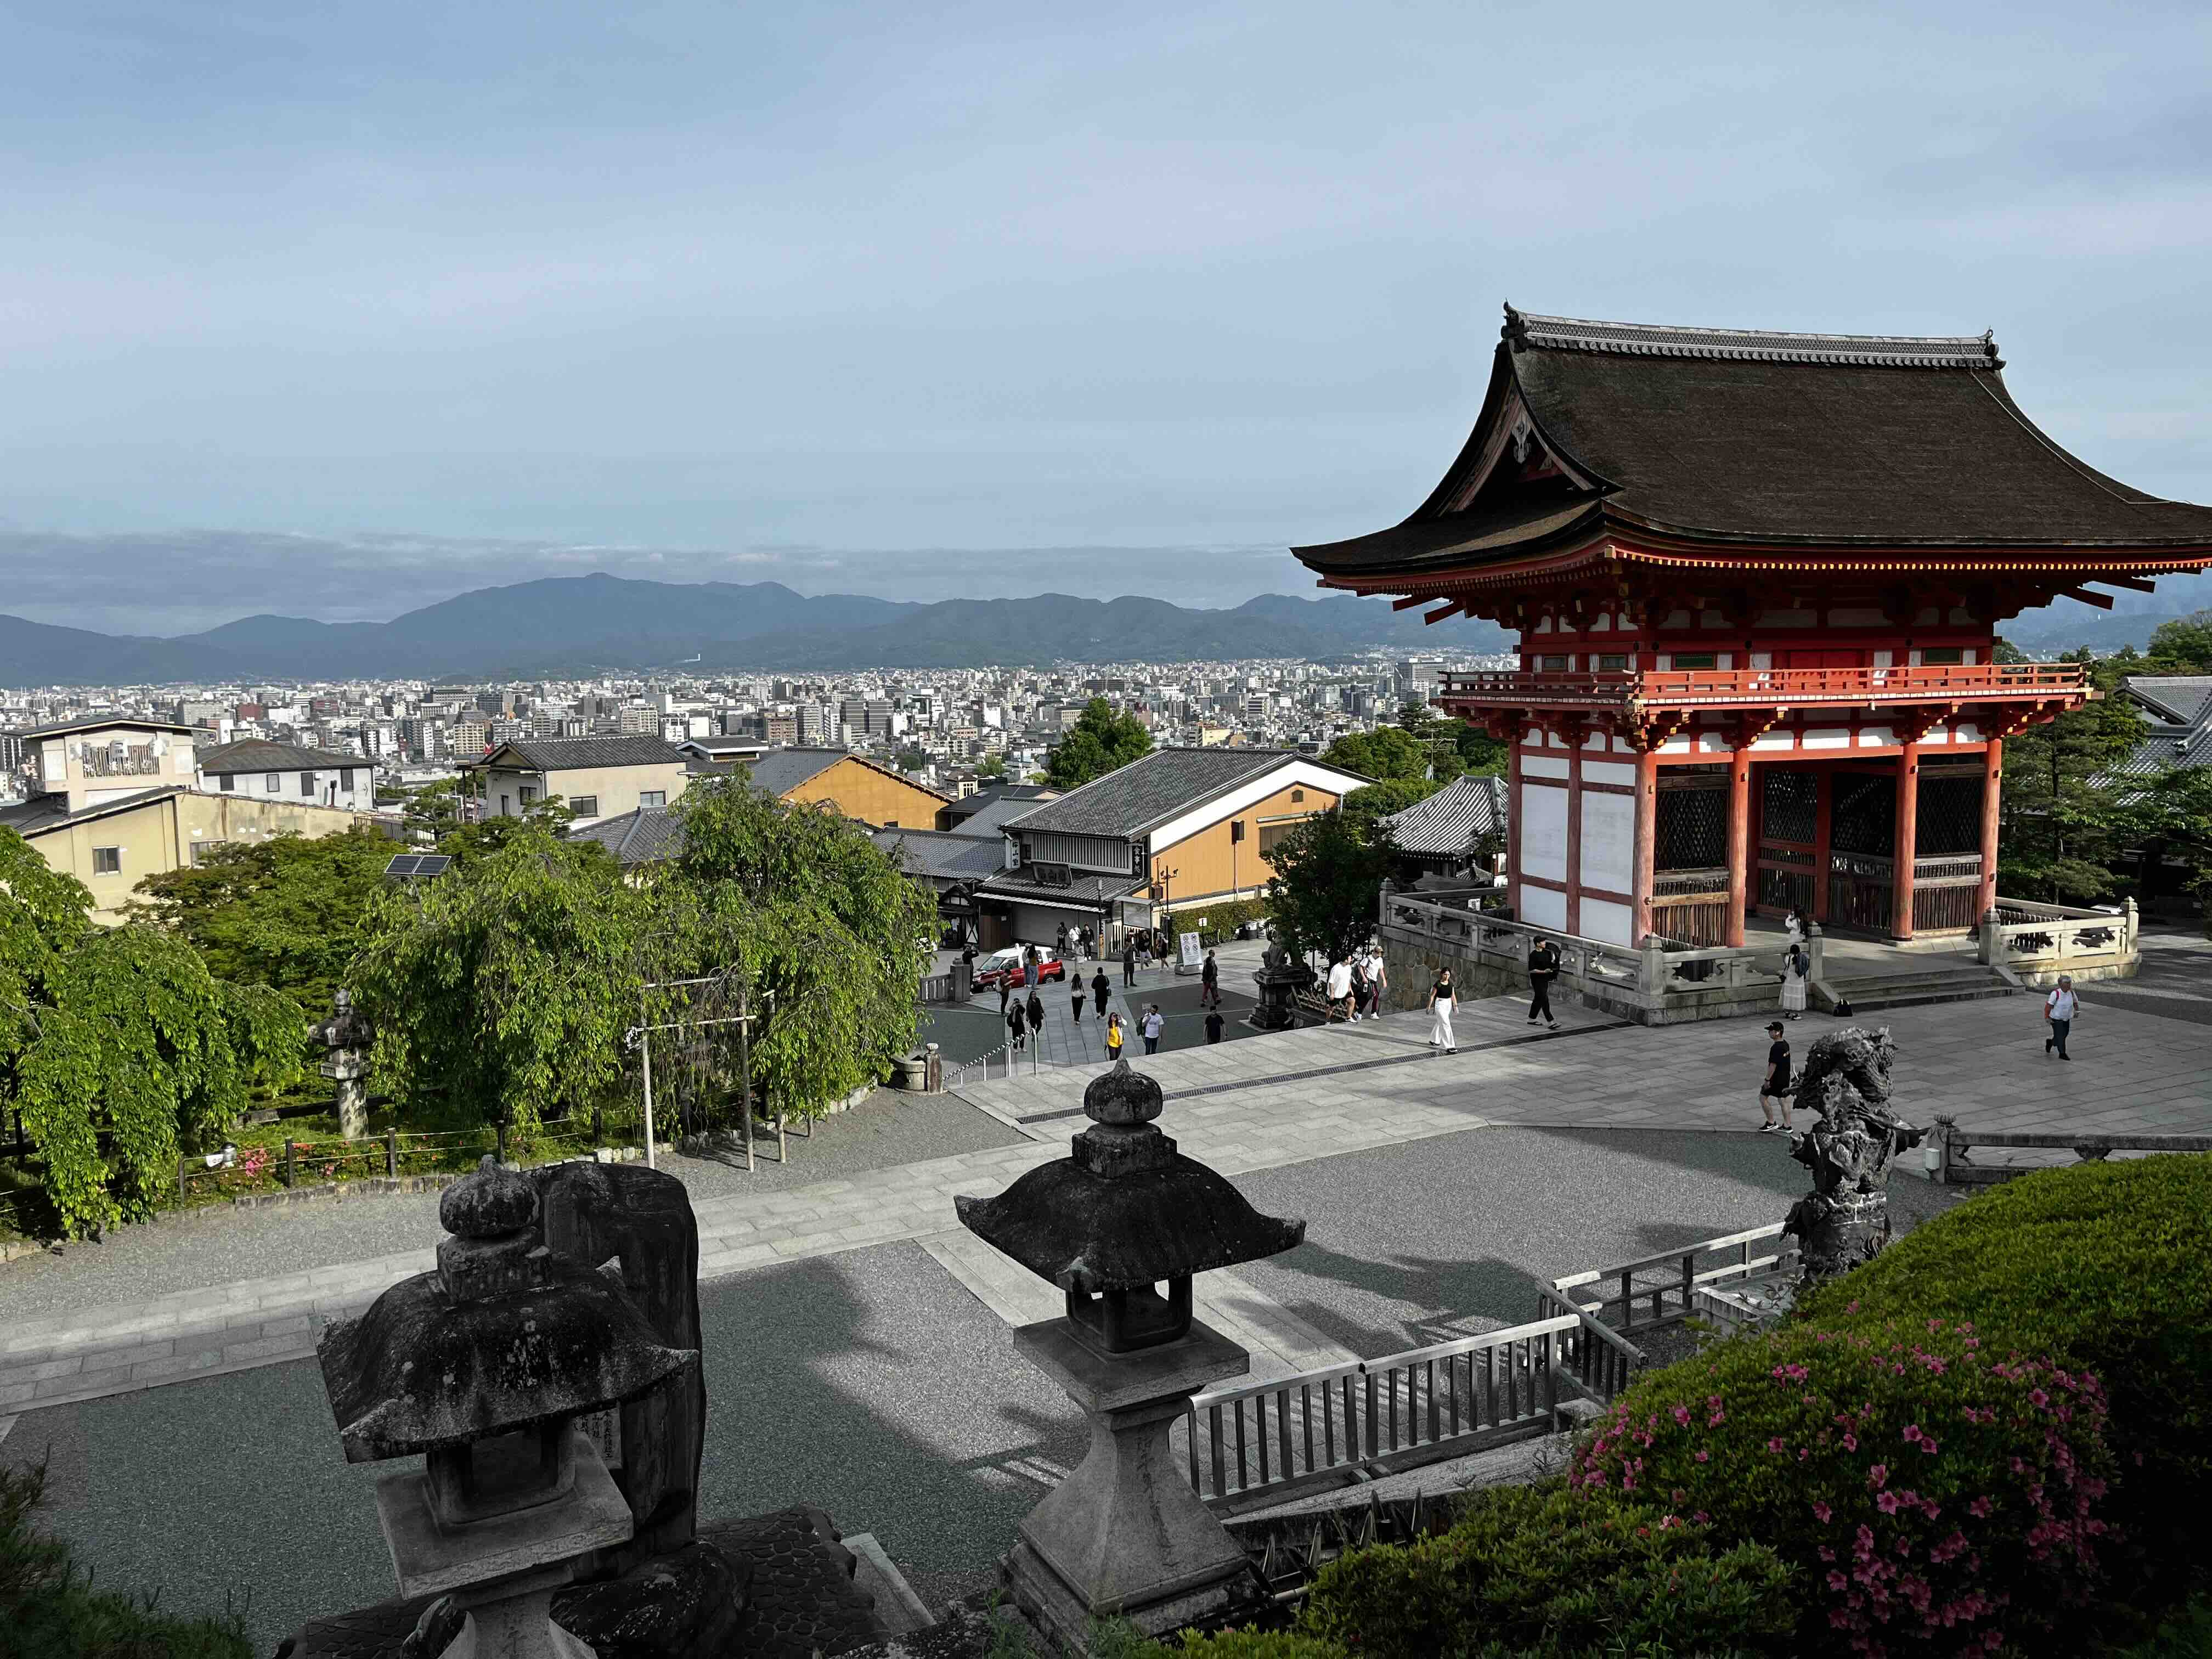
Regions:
[[0, 1088, 1022, 1323]]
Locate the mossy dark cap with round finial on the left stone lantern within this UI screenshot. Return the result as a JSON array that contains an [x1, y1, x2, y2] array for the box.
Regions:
[[317, 1159, 699, 1462]]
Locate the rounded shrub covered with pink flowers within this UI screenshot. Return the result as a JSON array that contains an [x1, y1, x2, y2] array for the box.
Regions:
[[1571, 1318, 2111, 1655]]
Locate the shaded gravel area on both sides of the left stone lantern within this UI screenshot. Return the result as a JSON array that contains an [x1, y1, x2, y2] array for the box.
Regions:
[[0, 1243, 1086, 1652]]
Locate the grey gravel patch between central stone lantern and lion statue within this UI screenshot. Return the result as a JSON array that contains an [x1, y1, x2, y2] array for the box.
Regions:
[[1234, 1128, 1957, 1358]]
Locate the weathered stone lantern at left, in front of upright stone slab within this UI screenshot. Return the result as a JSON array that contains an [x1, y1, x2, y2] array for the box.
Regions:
[[317, 1157, 699, 1659]]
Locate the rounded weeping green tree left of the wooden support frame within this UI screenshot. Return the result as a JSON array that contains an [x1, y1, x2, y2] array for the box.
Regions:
[[349, 819, 654, 1132]]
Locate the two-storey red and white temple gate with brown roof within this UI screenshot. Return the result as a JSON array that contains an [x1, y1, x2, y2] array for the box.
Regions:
[[1296, 307, 2212, 945]]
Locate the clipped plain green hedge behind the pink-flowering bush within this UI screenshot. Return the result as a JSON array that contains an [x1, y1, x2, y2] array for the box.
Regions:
[[1803, 1157, 2212, 1601]]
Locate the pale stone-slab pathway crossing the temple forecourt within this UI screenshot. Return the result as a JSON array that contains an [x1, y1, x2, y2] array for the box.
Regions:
[[0, 975, 2212, 1413]]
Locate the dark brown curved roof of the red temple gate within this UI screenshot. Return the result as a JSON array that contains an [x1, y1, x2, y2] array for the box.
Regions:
[[1294, 307, 2212, 577]]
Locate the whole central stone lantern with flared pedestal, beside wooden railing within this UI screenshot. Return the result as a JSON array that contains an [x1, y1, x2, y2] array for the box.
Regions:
[[953, 1059, 1305, 1652]]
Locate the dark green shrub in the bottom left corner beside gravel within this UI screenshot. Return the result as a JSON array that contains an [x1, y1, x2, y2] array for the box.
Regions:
[[0, 1466, 252, 1659]]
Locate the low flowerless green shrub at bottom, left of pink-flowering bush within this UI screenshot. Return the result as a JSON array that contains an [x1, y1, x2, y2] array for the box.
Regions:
[[1291, 1487, 1796, 1659]]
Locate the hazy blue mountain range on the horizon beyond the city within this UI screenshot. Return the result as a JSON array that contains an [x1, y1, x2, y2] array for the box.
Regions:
[[0, 575, 1506, 686]]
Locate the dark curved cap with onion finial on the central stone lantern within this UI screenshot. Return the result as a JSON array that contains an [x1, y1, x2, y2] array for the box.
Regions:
[[953, 1059, 1305, 1294]]
